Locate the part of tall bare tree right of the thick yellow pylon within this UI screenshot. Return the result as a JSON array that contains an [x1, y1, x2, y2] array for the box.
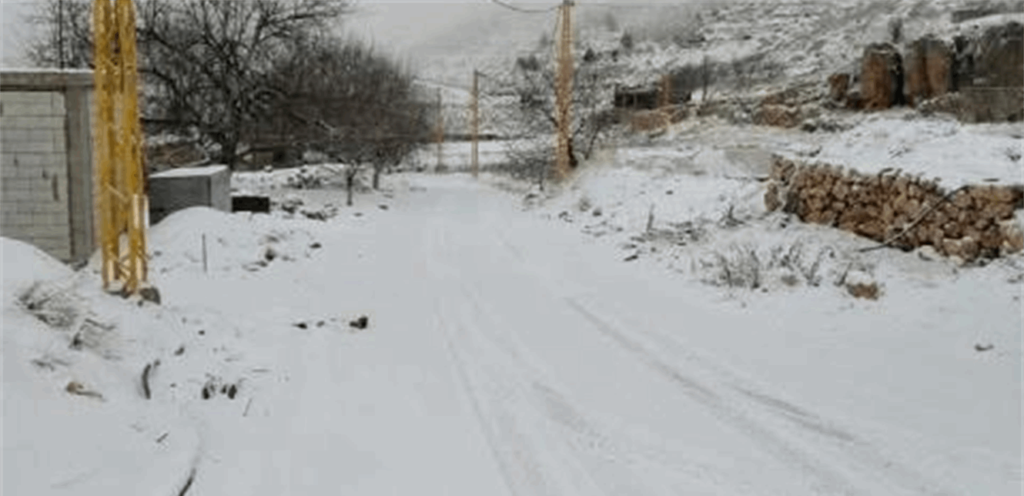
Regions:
[[139, 0, 349, 167]]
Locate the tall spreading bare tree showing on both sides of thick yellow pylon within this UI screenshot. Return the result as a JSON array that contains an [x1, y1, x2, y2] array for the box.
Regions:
[[30, 0, 352, 167]]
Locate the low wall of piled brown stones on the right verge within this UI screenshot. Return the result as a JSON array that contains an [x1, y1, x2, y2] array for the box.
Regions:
[[765, 156, 1024, 261]]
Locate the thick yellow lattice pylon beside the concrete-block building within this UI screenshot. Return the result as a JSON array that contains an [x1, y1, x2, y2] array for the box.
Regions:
[[92, 0, 148, 293]]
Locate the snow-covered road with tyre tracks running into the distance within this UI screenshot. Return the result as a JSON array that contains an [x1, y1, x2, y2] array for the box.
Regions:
[[155, 177, 1019, 495]]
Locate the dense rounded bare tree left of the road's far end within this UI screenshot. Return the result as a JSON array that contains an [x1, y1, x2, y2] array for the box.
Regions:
[[262, 36, 430, 199]]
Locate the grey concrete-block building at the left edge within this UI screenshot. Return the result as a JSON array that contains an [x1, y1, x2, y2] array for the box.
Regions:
[[0, 70, 95, 262]]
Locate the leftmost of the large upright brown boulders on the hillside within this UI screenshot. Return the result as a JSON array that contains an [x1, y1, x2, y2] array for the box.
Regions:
[[860, 43, 903, 110]]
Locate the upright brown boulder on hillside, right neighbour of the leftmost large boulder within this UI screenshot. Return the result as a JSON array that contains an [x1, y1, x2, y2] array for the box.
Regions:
[[903, 36, 953, 106]]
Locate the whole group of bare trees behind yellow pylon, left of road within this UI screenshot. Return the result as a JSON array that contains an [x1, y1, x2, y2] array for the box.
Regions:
[[29, 0, 429, 172]]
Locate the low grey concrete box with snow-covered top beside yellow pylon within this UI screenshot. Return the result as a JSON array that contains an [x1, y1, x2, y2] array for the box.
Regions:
[[148, 165, 231, 223]]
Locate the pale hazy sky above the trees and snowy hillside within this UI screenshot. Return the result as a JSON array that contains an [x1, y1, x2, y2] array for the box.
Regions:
[[0, 0, 559, 67]]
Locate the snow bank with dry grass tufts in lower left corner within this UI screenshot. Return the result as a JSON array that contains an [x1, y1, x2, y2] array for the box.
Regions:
[[0, 245, 199, 495]]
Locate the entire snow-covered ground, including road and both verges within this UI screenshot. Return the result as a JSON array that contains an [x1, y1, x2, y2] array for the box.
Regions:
[[0, 147, 1024, 495]]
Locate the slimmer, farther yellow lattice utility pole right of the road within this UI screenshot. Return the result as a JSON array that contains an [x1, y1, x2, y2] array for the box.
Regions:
[[555, 0, 573, 179]]
